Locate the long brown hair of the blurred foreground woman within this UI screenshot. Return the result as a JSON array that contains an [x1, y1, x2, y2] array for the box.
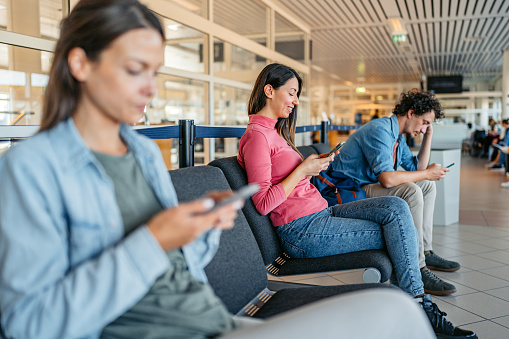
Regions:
[[40, 0, 164, 131]]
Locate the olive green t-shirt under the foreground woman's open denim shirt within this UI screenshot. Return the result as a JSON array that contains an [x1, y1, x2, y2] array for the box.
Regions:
[[94, 152, 234, 338]]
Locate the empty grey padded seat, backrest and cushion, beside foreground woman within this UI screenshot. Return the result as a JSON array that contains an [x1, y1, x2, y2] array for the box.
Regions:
[[170, 166, 395, 318]]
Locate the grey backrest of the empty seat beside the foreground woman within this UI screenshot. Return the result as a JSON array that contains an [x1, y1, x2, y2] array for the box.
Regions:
[[170, 166, 267, 314]]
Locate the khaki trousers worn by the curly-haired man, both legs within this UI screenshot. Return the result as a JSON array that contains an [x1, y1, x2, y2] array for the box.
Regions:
[[362, 180, 437, 268]]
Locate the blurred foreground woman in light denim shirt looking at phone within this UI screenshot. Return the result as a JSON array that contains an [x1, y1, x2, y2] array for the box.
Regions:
[[0, 0, 433, 339]]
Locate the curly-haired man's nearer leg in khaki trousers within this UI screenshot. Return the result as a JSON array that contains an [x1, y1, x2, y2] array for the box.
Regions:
[[362, 182, 426, 268]]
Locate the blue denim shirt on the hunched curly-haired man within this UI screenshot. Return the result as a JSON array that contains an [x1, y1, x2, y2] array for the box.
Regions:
[[331, 114, 418, 186]]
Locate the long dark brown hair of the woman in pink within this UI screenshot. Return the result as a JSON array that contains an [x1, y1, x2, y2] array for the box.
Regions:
[[247, 63, 302, 157]]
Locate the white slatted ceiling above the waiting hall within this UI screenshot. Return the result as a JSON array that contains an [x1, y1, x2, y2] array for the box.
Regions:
[[273, 0, 509, 85]]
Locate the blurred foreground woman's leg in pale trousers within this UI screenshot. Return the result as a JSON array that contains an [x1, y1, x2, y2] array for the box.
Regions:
[[221, 289, 436, 339]]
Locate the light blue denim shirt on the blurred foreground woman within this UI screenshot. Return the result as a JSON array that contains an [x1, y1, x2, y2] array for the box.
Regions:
[[0, 119, 220, 338]]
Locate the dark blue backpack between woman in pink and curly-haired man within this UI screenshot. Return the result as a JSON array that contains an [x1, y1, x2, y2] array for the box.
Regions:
[[310, 166, 366, 206]]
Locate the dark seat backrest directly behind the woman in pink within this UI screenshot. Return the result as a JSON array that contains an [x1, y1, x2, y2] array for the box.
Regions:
[[209, 156, 283, 266]]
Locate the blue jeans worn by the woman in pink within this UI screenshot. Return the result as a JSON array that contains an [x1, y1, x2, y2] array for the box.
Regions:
[[276, 197, 424, 296]]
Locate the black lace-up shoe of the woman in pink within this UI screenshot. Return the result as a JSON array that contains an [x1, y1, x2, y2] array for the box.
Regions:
[[420, 294, 478, 339]]
